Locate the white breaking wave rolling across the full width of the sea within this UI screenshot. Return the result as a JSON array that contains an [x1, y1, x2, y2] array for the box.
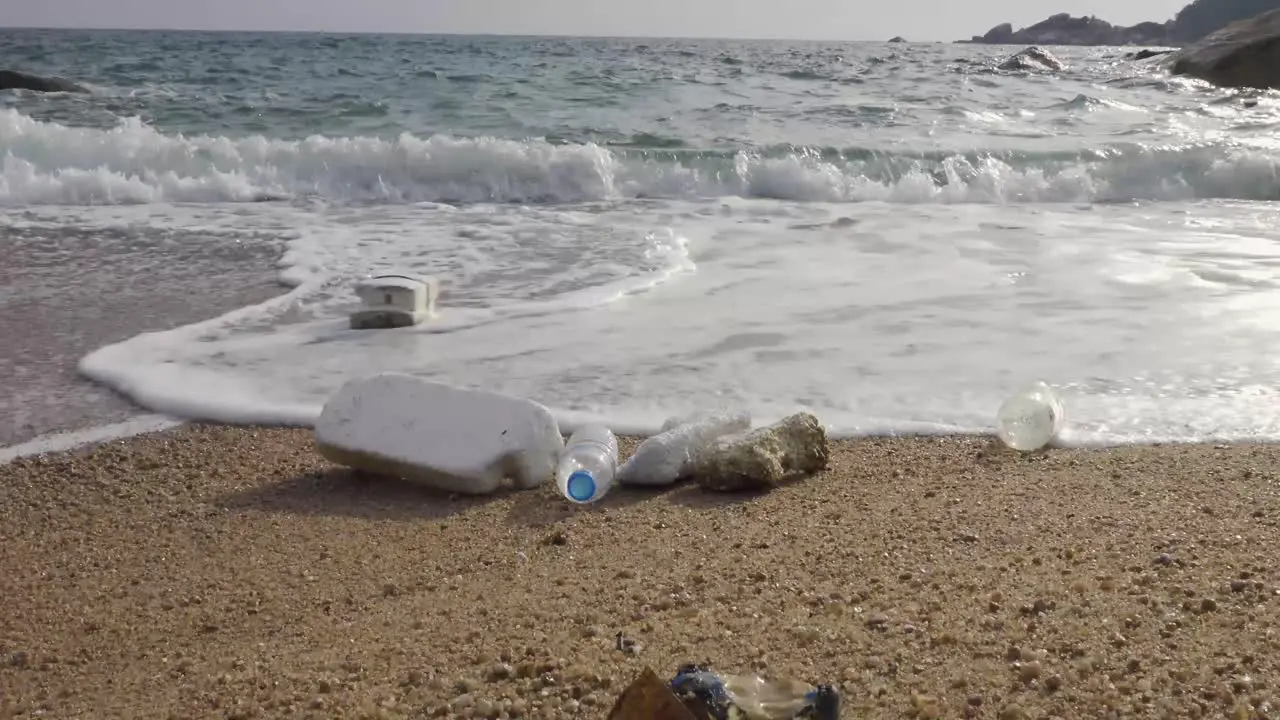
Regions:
[[0, 109, 1280, 208]]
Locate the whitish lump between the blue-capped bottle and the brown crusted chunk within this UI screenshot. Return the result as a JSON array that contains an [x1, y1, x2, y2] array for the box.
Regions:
[[618, 411, 751, 486]]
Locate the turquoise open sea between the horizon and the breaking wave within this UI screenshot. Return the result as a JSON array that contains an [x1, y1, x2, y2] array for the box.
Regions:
[[0, 31, 1268, 181]]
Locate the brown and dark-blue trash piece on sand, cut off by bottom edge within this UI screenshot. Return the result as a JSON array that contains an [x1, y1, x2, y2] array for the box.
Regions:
[[609, 664, 840, 720]]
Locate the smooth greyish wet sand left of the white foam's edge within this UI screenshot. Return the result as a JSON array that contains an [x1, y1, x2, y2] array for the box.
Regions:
[[0, 223, 285, 447]]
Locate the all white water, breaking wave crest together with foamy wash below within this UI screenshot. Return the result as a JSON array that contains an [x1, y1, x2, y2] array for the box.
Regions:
[[0, 111, 1280, 445]]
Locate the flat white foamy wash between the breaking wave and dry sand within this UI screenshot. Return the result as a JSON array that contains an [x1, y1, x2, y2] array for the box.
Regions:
[[60, 200, 1280, 445]]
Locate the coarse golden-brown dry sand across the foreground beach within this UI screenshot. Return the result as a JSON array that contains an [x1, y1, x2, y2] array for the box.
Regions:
[[0, 427, 1280, 719]]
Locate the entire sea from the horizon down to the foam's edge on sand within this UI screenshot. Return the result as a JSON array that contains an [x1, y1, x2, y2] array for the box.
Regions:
[[0, 31, 1280, 445]]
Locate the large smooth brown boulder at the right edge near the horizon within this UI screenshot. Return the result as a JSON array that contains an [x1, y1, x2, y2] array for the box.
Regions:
[[1170, 10, 1280, 90]]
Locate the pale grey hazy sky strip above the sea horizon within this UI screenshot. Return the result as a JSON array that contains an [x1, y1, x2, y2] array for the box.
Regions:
[[0, 0, 1187, 41]]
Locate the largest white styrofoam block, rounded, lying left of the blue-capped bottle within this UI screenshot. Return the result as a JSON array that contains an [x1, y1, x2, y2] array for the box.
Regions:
[[315, 373, 564, 495]]
